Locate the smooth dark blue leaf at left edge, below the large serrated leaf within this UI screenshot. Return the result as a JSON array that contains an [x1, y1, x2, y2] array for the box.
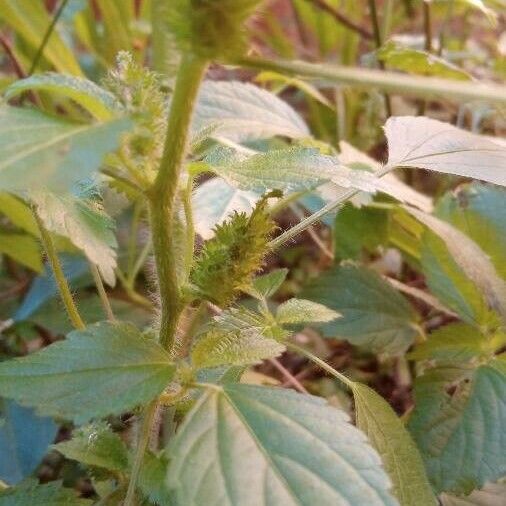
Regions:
[[0, 401, 58, 485]]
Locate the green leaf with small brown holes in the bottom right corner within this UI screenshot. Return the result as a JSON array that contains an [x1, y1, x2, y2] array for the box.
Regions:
[[409, 359, 506, 493]]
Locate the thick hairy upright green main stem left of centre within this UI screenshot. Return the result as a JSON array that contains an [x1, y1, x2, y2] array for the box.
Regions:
[[148, 55, 208, 351]]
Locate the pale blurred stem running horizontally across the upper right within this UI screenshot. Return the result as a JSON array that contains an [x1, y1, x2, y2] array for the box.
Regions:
[[233, 57, 506, 105]]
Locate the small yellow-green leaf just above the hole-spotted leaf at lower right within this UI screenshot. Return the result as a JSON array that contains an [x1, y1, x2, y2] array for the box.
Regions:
[[409, 323, 484, 364]]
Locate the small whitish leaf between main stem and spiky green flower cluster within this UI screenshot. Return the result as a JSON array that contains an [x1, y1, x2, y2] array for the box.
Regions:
[[193, 177, 259, 240]]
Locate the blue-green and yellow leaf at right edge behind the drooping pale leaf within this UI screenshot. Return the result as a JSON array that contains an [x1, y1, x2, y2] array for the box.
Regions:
[[435, 182, 506, 279]]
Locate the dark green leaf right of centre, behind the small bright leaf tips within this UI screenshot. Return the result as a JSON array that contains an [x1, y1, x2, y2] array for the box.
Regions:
[[300, 264, 418, 354]]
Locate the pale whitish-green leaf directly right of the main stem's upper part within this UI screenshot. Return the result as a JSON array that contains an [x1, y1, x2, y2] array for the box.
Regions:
[[193, 81, 309, 142]]
